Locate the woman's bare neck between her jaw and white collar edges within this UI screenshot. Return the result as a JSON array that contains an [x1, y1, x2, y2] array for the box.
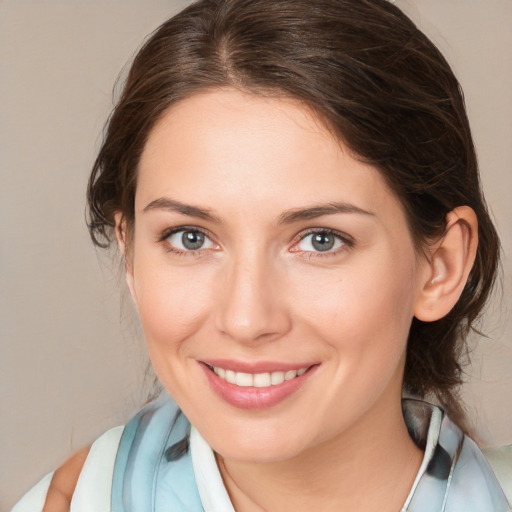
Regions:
[[217, 394, 423, 512]]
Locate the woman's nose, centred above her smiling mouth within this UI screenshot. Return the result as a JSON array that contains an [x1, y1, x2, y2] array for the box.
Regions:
[[216, 251, 291, 345]]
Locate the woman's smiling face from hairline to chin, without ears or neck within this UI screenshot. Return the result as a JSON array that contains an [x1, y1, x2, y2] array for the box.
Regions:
[[128, 89, 432, 461]]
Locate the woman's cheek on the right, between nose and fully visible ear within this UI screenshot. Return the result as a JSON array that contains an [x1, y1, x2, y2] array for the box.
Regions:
[[292, 253, 414, 359]]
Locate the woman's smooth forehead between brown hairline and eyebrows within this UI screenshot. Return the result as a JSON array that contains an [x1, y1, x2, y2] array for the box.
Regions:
[[136, 89, 404, 220]]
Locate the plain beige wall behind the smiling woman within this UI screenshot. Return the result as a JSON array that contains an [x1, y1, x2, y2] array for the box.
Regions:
[[0, 0, 512, 511]]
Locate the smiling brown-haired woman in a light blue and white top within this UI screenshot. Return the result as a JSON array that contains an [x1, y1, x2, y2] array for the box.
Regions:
[[15, 0, 510, 512]]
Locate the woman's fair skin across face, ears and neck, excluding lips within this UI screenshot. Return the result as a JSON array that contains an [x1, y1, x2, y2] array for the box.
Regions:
[[45, 89, 477, 512]]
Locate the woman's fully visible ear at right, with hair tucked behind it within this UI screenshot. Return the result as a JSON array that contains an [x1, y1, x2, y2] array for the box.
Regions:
[[414, 206, 478, 322]]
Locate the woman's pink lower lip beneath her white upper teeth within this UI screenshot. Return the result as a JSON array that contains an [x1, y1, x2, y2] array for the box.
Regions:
[[200, 363, 318, 409]]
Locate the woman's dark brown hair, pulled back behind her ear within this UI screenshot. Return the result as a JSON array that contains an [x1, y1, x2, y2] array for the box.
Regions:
[[88, 0, 499, 420]]
